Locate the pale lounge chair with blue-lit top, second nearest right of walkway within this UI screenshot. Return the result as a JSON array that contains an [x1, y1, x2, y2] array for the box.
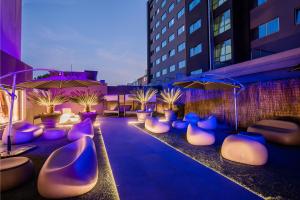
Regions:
[[186, 124, 215, 146]]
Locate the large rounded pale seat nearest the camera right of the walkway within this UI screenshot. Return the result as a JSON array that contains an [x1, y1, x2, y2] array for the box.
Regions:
[[221, 134, 268, 165]]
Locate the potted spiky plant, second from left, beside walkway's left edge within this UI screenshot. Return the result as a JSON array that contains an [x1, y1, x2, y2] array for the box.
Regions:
[[70, 89, 103, 122]]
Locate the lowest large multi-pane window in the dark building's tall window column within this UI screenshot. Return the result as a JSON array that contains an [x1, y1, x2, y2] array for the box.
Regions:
[[214, 39, 232, 63]]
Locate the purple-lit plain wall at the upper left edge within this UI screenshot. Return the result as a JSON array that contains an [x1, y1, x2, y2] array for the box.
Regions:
[[0, 0, 22, 60]]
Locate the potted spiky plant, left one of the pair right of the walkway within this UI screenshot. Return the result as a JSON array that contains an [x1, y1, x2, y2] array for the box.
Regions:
[[133, 88, 157, 122]]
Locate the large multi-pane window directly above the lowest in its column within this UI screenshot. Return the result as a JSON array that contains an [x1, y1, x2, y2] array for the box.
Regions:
[[214, 10, 231, 36]]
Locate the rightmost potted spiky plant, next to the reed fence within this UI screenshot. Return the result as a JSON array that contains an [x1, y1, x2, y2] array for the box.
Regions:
[[160, 88, 182, 122]]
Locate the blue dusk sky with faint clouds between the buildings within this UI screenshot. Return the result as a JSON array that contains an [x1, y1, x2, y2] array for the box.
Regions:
[[22, 0, 147, 85]]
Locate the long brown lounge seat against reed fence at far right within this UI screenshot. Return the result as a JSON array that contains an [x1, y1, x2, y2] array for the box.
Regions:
[[247, 120, 300, 145]]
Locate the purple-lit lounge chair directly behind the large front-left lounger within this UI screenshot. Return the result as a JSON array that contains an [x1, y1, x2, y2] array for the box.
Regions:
[[68, 118, 94, 141]]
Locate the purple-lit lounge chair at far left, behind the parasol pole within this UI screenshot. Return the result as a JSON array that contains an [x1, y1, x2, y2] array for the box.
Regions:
[[2, 121, 43, 144]]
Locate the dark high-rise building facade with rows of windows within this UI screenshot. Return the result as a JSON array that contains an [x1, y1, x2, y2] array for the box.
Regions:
[[147, 0, 300, 85]]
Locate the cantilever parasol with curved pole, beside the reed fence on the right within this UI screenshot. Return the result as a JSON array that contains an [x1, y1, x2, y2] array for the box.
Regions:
[[173, 74, 244, 131]]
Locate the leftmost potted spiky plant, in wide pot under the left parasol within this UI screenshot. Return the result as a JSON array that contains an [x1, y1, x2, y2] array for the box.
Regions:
[[27, 90, 68, 128]]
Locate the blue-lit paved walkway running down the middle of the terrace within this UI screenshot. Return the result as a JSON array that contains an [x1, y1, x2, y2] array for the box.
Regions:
[[101, 118, 261, 200]]
